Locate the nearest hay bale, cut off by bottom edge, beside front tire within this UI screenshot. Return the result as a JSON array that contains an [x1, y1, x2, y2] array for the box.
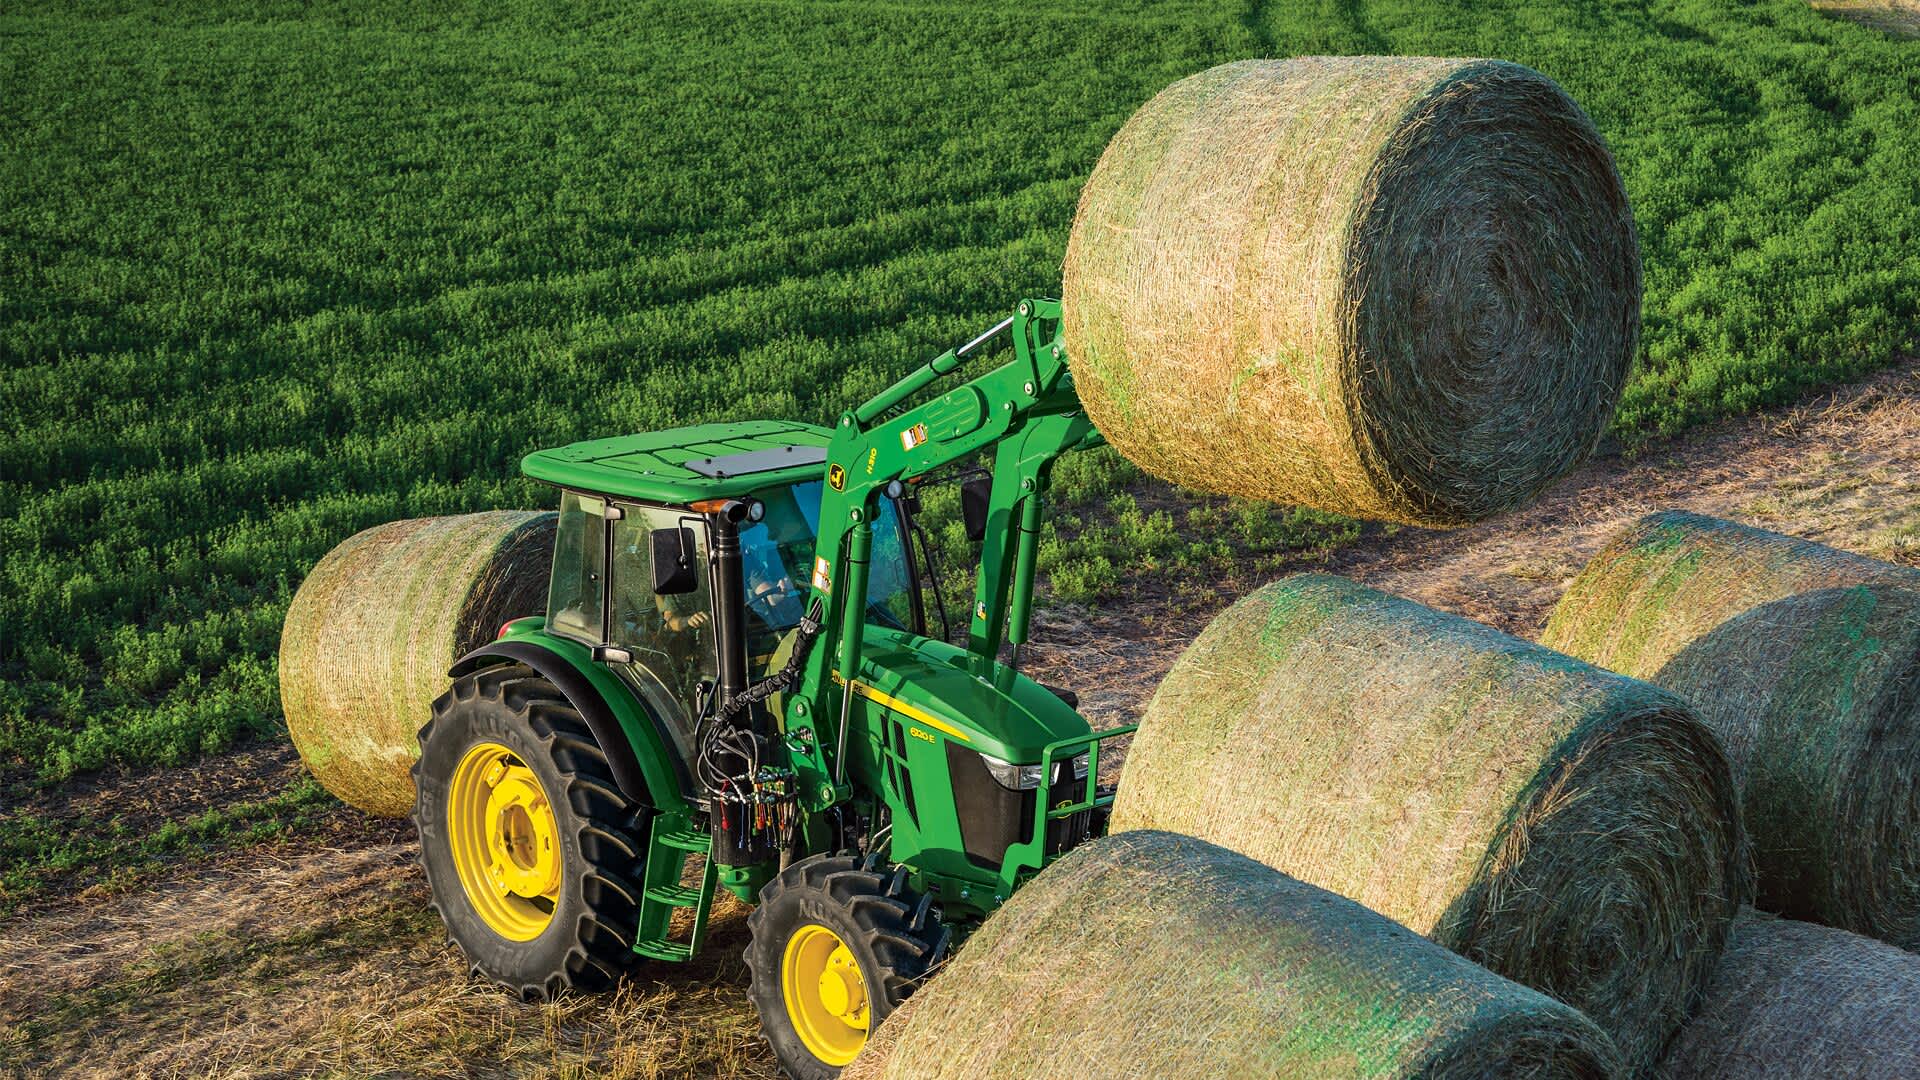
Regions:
[[843, 832, 1619, 1080]]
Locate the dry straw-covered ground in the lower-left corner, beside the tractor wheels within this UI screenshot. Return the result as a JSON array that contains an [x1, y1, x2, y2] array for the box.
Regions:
[[0, 844, 778, 1080]]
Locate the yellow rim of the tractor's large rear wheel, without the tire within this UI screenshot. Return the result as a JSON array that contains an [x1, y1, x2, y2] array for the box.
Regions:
[[447, 742, 561, 942]]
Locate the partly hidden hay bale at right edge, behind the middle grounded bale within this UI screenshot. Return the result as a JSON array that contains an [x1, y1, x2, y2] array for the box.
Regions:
[[1542, 513, 1920, 947]]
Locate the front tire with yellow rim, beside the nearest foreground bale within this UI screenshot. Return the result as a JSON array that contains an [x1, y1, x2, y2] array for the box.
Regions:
[[747, 855, 950, 1080]]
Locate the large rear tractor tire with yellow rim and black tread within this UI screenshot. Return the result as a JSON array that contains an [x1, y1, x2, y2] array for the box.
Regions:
[[413, 663, 647, 1001]]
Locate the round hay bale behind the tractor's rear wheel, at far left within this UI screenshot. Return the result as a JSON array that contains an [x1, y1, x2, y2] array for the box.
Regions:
[[280, 509, 557, 817]]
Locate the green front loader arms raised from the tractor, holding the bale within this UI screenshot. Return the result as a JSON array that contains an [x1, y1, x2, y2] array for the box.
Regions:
[[787, 300, 1102, 809]]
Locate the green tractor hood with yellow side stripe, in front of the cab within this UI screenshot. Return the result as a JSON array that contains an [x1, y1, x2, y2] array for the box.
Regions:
[[854, 625, 1092, 765]]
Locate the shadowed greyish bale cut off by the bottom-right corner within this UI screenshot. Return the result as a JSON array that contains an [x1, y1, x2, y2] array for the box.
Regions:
[[1661, 913, 1920, 1080]]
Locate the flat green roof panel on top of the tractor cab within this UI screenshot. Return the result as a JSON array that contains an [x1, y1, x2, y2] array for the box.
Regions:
[[520, 421, 833, 503]]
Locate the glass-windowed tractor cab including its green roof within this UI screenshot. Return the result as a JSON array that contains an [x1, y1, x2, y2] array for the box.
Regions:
[[524, 423, 925, 772]]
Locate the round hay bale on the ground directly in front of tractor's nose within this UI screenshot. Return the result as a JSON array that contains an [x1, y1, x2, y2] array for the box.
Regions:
[[1114, 575, 1749, 1070]]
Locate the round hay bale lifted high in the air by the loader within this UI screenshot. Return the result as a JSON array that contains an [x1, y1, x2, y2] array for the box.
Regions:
[[1062, 56, 1640, 527]]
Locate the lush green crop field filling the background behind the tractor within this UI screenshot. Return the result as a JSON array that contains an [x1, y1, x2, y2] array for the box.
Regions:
[[0, 0, 1920, 780]]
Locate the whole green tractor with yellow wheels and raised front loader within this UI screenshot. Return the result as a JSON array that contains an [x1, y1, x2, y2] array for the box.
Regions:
[[413, 300, 1133, 1080]]
